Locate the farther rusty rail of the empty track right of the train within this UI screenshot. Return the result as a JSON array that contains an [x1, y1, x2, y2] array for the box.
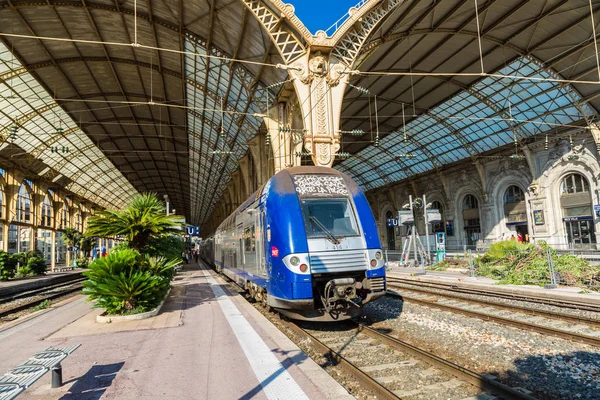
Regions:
[[388, 284, 600, 326]]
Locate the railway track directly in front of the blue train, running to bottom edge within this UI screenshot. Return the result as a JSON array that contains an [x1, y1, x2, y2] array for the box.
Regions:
[[288, 321, 534, 400]]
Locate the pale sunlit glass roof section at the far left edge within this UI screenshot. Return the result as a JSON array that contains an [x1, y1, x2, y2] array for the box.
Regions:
[[0, 44, 137, 208]]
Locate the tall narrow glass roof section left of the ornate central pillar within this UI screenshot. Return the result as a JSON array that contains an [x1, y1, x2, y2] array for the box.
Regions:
[[185, 39, 265, 222]]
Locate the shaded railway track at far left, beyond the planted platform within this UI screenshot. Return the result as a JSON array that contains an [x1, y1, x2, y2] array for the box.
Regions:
[[0, 277, 86, 321]]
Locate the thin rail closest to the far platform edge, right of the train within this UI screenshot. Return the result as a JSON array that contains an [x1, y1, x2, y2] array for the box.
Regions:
[[387, 276, 600, 312]]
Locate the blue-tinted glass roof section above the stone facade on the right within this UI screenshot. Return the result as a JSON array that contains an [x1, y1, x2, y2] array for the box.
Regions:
[[336, 57, 595, 189]]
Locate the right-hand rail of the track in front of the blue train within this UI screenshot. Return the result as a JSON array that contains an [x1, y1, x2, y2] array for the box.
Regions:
[[357, 322, 536, 400]]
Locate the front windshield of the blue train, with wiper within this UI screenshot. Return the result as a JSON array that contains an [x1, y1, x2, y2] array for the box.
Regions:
[[300, 198, 359, 239]]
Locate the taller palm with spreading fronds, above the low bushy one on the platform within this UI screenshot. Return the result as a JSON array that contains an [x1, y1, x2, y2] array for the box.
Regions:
[[87, 193, 183, 253]]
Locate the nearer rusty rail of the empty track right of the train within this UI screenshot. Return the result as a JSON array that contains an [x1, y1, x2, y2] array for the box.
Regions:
[[389, 293, 600, 347]]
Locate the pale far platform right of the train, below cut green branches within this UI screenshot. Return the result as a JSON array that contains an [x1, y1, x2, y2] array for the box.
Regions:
[[386, 266, 600, 307]]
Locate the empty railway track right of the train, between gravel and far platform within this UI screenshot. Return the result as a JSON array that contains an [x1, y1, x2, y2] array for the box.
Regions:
[[388, 281, 600, 347]]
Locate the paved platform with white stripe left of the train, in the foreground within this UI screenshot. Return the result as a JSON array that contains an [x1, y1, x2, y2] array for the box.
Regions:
[[0, 264, 354, 400]]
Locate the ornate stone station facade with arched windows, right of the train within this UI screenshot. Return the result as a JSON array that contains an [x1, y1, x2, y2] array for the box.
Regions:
[[367, 130, 600, 250]]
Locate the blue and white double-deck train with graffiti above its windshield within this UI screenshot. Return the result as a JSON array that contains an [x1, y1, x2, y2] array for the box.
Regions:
[[201, 167, 386, 321]]
